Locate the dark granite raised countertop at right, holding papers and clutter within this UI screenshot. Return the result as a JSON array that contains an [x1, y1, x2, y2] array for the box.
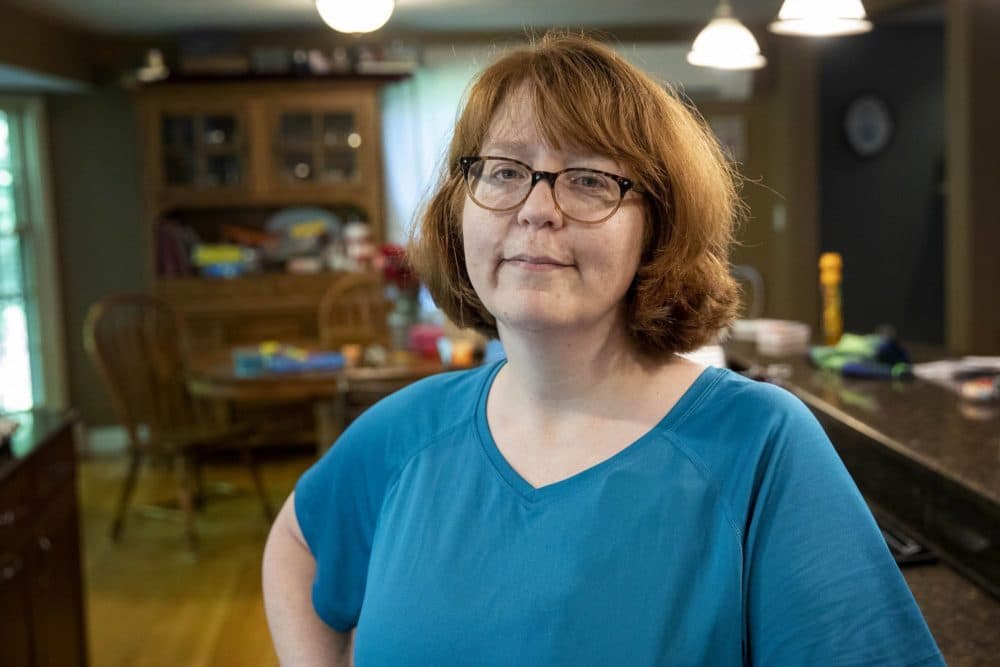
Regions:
[[725, 342, 1000, 508]]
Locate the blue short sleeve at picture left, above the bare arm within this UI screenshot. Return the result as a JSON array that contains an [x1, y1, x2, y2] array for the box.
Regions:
[[295, 419, 390, 632]]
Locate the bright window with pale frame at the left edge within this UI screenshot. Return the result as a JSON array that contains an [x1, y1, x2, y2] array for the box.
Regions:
[[0, 98, 64, 413]]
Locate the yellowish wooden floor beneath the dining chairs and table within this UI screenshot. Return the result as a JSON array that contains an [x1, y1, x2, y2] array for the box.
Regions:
[[80, 457, 311, 667]]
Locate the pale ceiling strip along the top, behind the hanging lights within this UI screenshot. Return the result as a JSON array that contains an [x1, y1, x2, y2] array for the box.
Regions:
[[13, 0, 781, 34]]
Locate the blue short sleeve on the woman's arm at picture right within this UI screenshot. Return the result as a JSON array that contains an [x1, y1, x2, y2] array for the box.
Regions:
[[744, 396, 944, 666]]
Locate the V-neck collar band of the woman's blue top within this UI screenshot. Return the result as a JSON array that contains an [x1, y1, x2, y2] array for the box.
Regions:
[[475, 360, 723, 503]]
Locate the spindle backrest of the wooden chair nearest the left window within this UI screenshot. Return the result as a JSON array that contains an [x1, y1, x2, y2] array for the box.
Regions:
[[83, 294, 201, 445]]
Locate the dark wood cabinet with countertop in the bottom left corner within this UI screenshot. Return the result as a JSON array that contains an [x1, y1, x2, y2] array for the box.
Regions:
[[0, 412, 87, 667]]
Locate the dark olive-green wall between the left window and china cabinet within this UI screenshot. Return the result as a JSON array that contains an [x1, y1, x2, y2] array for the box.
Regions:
[[48, 89, 151, 424]]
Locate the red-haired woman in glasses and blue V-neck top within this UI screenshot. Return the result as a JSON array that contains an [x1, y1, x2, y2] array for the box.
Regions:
[[264, 35, 942, 665]]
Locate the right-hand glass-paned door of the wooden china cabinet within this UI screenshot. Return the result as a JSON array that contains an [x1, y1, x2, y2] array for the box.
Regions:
[[274, 109, 363, 185]]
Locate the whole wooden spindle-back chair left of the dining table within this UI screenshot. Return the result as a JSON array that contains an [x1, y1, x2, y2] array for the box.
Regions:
[[84, 294, 274, 551]]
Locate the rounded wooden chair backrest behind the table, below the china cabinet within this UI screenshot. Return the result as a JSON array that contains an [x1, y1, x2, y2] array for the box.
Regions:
[[319, 273, 392, 350]]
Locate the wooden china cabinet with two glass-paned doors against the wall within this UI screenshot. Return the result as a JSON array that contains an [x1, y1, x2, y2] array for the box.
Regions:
[[139, 77, 386, 349]]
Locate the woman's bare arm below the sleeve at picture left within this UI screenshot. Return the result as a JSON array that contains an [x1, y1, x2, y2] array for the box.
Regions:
[[263, 493, 352, 667]]
